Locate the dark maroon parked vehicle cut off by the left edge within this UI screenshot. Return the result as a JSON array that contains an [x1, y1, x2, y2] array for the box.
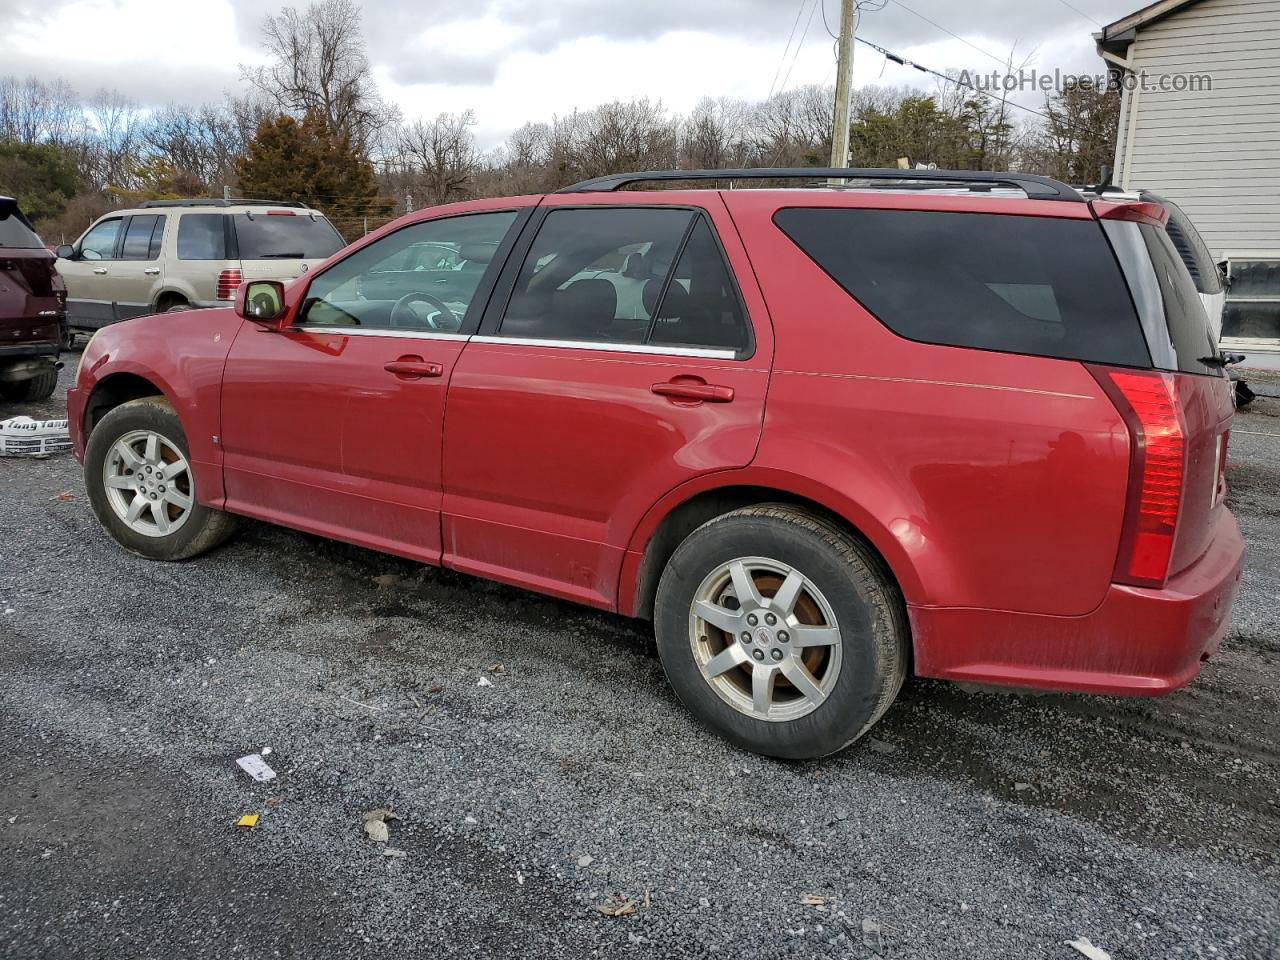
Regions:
[[0, 197, 67, 401]]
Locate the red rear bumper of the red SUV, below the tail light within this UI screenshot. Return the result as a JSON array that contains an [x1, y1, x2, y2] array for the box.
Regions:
[[908, 509, 1244, 696]]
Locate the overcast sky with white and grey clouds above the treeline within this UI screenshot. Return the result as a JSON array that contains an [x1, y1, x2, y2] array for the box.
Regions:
[[0, 0, 1143, 147]]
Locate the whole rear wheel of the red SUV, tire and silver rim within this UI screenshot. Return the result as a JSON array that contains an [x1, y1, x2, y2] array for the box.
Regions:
[[654, 504, 908, 759]]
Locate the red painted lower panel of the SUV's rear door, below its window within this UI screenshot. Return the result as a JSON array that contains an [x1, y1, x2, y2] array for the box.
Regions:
[[444, 338, 768, 608]]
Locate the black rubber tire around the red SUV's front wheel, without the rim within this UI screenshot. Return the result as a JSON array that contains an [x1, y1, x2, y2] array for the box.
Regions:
[[84, 397, 236, 561]]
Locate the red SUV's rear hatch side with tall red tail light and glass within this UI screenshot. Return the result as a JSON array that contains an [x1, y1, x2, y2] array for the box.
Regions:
[[1093, 201, 1235, 586]]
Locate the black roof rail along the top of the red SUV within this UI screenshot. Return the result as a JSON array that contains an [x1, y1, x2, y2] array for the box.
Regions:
[[557, 166, 1084, 204]]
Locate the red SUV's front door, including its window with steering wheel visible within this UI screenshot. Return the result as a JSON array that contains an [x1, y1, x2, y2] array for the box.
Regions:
[[221, 201, 520, 563]]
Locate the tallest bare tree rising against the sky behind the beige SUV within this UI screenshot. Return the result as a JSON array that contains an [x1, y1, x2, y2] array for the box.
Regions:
[[241, 0, 398, 150]]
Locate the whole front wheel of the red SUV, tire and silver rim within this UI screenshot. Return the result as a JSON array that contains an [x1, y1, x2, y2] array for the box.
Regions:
[[84, 397, 234, 561]]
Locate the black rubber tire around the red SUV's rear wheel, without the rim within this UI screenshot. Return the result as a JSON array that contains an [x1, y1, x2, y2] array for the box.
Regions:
[[654, 504, 910, 759]]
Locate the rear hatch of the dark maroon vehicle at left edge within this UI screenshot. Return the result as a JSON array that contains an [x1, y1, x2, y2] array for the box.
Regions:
[[0, 197, 67, 346]]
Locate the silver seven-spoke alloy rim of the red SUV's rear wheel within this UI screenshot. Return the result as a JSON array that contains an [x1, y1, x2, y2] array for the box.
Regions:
[[689, 557, 841, 722]]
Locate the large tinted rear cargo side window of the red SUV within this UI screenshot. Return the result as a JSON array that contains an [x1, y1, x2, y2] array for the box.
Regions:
[[774, 207, 1151, 366]]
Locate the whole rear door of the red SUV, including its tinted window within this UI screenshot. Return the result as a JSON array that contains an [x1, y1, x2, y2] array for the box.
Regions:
[[443, 192, 773, 608]]
